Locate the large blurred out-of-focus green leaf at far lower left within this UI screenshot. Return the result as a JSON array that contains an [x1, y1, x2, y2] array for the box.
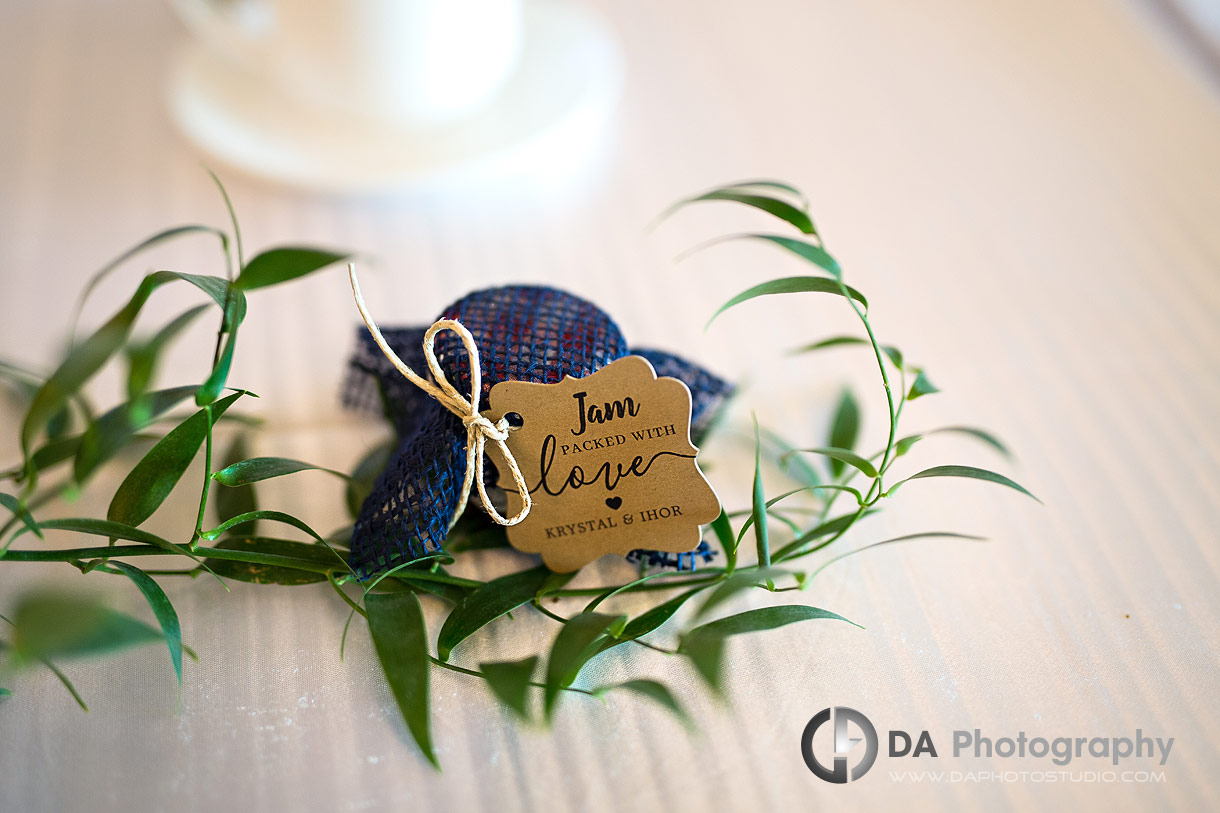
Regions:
[[13, 592, 162, 660]]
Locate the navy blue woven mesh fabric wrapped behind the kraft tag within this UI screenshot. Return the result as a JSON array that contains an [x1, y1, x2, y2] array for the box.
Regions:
[[343, 286, 732, 577]]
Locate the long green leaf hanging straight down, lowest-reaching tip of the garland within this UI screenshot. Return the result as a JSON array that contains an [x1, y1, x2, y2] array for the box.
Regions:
[[365, 591, 440, 770]]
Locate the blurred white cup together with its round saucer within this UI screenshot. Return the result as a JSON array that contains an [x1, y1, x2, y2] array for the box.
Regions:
[[170, 0, 622, 193]]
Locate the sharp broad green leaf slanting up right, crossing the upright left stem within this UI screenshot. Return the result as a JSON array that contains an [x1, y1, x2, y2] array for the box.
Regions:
[[106, 391, 245, 525]]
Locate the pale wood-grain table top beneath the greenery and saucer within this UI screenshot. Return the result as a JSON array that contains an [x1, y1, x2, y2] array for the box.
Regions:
[[0, 0, 1220, 812]]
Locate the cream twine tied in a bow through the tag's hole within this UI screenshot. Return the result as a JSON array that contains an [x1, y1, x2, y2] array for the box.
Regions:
[[348, 262, 533, 527]]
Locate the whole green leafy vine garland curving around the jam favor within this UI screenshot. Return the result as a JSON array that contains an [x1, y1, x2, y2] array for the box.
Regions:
[[0, 176, 1032, 767]]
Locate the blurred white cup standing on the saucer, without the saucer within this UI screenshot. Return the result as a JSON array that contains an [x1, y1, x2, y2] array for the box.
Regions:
[[173, 0, 521, 125]]
